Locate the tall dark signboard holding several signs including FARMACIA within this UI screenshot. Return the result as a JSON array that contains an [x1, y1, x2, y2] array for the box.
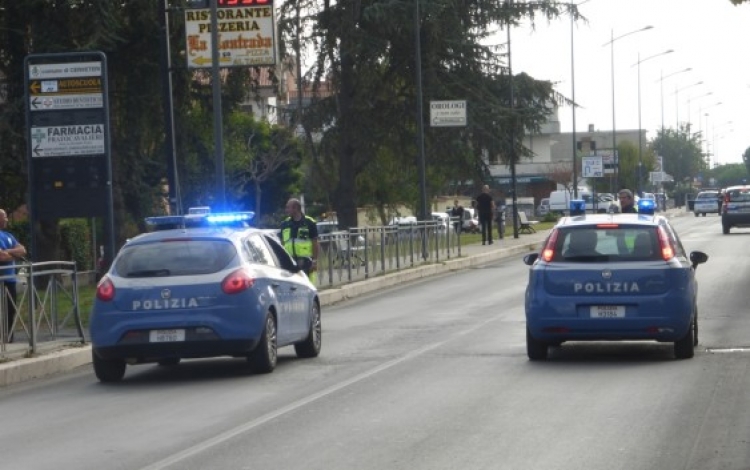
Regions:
[[24, 51, 114, 259]]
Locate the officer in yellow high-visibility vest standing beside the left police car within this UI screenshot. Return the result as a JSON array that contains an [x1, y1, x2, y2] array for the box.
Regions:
[[279, 199, 320, 284]]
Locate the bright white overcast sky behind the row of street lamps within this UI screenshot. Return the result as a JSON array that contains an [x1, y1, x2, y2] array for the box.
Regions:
[[502, 0, 750, 166]]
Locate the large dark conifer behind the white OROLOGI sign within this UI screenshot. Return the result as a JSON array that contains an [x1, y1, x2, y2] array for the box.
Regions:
[[281, 0, 577, 225]]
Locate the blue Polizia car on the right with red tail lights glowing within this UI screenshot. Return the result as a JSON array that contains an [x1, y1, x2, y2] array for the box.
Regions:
[[524, 200, 708, 360]]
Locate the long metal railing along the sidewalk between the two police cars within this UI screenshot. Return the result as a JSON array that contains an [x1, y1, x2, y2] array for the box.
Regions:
[[317, 218, 461, 288]]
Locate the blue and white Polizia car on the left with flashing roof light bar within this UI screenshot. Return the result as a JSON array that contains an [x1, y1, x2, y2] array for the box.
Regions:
[[91, 213, 321, 382]]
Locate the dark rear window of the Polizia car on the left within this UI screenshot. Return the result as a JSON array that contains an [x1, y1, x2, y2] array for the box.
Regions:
[[115, 239, 237, 277]]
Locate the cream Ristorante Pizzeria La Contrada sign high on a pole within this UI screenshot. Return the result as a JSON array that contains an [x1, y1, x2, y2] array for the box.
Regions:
[[185, 0, 276, 68]]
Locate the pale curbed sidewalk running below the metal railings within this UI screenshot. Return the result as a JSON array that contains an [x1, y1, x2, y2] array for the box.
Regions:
[[0, 208, 688, 387]]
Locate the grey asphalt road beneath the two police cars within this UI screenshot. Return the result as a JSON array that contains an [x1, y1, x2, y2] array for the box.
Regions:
[[0, 216, 750, 470]]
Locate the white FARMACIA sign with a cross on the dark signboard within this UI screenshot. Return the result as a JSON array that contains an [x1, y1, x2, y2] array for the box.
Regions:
[[31, 124, 104, 158]]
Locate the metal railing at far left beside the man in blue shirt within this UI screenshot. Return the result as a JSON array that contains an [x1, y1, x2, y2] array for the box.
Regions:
[[0, 261, 85, 358]]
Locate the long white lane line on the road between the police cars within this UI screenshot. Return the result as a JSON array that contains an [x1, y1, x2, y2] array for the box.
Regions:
[[142, 316, 503, 470]]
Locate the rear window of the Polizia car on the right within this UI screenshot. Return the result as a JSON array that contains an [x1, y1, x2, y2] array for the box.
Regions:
[[553, 226, 661, 262]]
